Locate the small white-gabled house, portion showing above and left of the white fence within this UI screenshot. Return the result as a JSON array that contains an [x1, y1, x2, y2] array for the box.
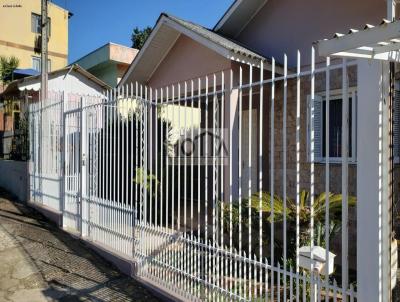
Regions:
[[0, 65, 110, 159]]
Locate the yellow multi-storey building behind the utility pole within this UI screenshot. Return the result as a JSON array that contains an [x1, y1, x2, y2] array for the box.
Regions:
[[0, 0, 71, 71]]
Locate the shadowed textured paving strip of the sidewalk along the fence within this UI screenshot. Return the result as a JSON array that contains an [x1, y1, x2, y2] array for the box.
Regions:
[[0, 189, 158, 302]]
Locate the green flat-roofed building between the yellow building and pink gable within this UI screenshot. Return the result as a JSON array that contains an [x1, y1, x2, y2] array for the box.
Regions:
[[74, 43, 138, 87]]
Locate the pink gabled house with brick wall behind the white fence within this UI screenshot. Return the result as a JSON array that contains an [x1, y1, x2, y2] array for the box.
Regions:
[[115, 0, 400, 280]]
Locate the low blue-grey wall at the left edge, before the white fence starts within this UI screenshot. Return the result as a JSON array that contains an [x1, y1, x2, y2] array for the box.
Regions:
[[0, 160, 28, 202]]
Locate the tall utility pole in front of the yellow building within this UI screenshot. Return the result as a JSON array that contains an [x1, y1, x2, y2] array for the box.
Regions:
[[41, 0, 49, 105]]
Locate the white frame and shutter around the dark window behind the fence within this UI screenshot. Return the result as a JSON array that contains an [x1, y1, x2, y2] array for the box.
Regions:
[[307, 87, 358, 164]]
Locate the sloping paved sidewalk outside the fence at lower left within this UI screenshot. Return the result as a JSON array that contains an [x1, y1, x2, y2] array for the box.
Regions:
[[0, 189, 158, 302]]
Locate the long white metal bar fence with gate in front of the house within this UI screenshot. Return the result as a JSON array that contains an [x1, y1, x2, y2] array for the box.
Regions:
[[30, 47, 376, 301]]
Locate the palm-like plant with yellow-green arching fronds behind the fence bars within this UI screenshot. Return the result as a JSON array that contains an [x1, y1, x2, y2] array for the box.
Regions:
[[221, 191, 356, 257]]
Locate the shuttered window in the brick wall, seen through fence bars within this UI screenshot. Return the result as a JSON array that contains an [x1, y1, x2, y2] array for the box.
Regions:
[[307, 89, 357, 162]]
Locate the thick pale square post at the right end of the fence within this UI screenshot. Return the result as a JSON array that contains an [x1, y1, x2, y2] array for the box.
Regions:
[[357, 60, 391, 302]]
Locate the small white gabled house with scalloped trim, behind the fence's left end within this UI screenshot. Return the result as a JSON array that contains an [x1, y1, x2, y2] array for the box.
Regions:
[[0, 65, 110, 193]]
